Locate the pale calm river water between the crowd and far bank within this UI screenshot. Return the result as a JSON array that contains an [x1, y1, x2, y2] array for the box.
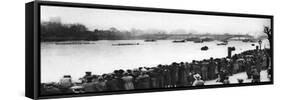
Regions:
[[41, 40, 269, 82]]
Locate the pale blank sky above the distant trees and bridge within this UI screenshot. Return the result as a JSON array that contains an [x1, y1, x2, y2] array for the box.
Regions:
[[41, 6, 270, 35]]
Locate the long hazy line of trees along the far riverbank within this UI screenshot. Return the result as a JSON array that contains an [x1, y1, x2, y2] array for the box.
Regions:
[[40, 21, 272, 42]]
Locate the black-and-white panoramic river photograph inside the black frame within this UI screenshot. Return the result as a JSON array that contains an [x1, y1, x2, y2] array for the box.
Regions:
[[40, 5, 273, 95]]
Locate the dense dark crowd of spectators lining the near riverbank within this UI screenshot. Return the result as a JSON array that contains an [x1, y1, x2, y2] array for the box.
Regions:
[[41, 49, 271, 95]]
